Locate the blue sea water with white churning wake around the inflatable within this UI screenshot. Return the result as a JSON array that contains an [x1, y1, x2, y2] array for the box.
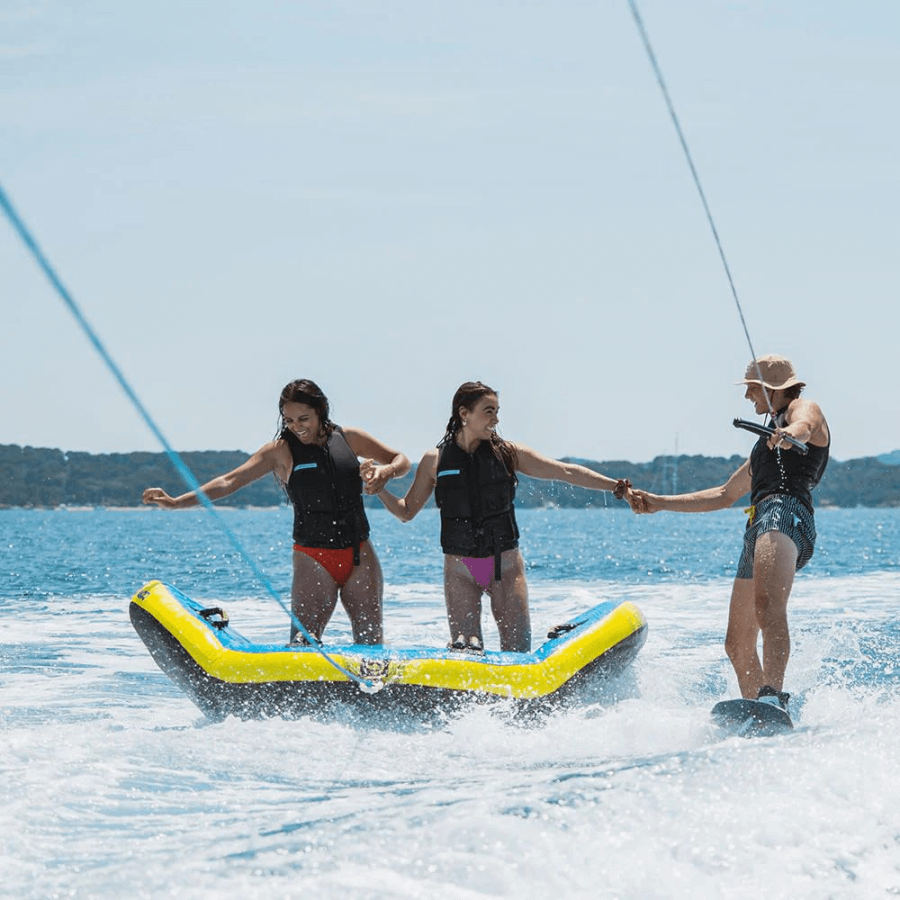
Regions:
[[0, 509, 900, 900]]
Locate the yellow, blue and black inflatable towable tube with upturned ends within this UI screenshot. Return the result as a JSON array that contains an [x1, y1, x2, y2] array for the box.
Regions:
[[130, 581, 647, 719]]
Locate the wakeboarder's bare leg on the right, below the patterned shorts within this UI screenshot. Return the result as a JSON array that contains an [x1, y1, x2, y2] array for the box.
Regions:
[[753, 531, 797, 691]]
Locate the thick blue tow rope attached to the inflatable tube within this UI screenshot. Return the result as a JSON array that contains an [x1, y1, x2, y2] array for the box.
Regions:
[[0, 186, 379, 693]]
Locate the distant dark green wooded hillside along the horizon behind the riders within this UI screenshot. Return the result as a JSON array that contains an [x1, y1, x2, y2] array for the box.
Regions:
[[0, 444, 900, 507]]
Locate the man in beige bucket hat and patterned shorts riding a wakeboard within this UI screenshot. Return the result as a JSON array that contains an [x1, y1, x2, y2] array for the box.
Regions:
[[628, 355, 831, 710]]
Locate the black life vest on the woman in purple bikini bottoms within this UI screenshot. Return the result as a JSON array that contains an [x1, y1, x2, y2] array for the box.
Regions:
[[434, 441, 519, 581]]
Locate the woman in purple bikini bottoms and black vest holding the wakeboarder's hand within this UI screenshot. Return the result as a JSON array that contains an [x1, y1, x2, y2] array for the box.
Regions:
[[370, 381, 629, 653]]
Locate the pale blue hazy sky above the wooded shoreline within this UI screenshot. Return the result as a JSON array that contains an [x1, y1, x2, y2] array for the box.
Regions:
[[0, 0, 900, 464]]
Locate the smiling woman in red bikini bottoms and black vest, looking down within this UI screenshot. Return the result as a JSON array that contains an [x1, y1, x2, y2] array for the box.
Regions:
[[143, 379, 409, 644]]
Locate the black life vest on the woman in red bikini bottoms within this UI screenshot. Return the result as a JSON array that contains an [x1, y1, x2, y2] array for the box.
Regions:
[[281, 428, 369, 563]]
